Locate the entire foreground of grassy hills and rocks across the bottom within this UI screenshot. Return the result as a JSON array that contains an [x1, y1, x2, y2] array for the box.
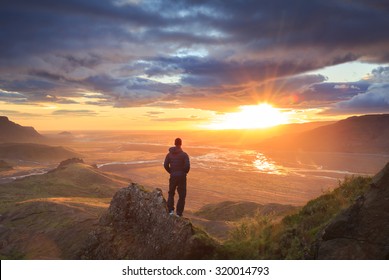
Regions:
[[0, 156, 389, 259]]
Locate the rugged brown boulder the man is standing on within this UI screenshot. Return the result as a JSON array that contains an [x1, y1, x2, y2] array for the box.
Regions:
[[80, 184, 216, 259]]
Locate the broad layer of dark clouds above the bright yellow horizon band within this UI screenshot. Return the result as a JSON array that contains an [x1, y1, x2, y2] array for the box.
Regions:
[[0, 0, 389, 114]]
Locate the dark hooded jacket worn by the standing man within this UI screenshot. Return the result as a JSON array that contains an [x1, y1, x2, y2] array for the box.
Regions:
[[163, 147, 190, 176]]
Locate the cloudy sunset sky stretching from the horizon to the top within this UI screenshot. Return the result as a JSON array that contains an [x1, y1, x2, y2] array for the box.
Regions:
[[0, 0, 389, 130]]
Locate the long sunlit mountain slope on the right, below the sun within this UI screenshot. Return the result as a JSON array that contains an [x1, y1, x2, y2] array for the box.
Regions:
[[259, 114, 389, 154]]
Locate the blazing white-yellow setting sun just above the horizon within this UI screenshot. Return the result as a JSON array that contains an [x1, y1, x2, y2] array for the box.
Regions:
[[207, 103, 288, 129]]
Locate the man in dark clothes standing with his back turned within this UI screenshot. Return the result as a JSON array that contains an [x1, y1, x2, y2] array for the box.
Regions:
[[163, 138, 190, 217]]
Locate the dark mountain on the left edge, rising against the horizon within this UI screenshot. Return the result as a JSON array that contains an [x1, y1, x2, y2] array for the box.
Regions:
[[0, 116, 45, 143]]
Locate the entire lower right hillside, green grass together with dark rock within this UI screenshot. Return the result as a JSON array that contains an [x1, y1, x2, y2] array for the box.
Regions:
[[218, 163, 389, 260]]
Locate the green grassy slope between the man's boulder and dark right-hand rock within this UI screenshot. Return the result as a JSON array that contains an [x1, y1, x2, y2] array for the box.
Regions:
[[219, 177, 371, 259]]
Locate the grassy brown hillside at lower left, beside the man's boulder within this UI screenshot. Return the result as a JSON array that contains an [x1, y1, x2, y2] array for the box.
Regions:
[[0, 163, 128, 259]]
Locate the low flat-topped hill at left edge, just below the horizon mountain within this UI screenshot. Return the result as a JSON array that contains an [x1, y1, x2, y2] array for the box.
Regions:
[[0, 143, 81, 162]]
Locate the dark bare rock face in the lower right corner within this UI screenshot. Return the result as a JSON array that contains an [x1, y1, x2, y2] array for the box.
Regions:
[[316, 163, 389, 259]]
